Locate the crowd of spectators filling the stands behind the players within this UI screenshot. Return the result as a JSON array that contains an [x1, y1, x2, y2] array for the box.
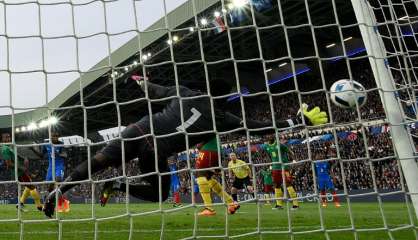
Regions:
[[0, 128, 401, 202]]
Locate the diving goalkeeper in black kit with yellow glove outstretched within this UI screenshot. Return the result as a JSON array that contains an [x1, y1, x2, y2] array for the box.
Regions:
[[44, 76, 327, 217]]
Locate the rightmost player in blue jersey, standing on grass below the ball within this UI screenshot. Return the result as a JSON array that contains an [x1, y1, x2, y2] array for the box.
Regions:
[[315, 154, 341, 207]]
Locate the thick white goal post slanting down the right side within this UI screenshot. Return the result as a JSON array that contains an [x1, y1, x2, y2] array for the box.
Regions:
[[351, 0, 418, 218]]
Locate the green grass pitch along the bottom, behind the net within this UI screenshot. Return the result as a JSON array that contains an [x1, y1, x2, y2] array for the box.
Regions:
[[0, 202, 417, 240]]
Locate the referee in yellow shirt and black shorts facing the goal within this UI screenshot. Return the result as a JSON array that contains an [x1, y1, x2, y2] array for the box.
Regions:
[[228, 153, 254, 202]]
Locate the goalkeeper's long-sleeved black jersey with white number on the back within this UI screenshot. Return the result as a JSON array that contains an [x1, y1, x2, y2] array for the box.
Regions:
[[137, 83, 298, 154]]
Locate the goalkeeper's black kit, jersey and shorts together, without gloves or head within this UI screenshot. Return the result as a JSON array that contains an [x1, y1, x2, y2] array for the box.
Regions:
[[80, 83, 298, 204]]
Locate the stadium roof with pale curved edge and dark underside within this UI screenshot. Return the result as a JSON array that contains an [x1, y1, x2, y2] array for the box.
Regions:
[[0, 0, 358, 134]]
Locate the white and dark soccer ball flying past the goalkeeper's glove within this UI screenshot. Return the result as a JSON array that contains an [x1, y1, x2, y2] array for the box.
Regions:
[[330, 79, 367, 108]]
